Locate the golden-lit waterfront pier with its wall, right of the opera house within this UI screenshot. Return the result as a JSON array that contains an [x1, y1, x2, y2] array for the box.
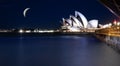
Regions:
[[95, 25, 120, 50]]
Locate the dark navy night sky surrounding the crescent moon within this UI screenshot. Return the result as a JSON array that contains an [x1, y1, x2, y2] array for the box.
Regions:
[[0, 0, 116, 29]]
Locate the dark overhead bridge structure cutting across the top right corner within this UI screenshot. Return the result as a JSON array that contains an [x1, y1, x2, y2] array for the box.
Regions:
[[100, 0, 120, 18]]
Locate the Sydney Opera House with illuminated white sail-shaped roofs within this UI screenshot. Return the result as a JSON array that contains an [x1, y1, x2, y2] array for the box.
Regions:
[[61, 11, 98, 32]]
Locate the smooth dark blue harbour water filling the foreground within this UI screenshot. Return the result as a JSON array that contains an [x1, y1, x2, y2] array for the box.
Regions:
[[0, 36, 120, 66]]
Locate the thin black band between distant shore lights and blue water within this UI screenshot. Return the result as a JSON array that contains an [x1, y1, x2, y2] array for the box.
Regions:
[[0, 32, 94, 37]]
